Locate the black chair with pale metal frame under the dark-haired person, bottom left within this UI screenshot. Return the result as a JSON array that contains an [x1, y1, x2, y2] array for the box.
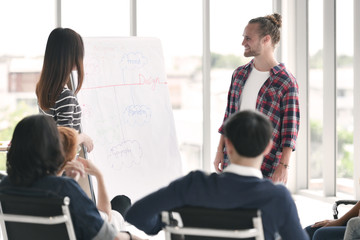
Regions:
[[0, 194, 76, 240]]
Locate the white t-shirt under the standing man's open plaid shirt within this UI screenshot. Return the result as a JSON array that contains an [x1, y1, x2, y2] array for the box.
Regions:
[[240, 67, 270, 111]]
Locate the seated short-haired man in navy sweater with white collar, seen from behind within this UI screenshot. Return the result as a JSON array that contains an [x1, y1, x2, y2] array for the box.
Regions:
[[125, 111, 308, 240]]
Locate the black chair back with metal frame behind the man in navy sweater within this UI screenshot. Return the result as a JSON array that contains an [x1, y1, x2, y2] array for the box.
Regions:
[[162, 207, 265, 240]]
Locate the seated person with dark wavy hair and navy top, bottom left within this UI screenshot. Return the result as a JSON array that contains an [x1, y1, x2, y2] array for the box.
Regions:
[[0, 115, 146, 240]]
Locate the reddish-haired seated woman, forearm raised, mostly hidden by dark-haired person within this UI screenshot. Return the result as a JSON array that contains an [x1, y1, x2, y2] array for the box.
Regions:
[[58, 126, 131, 231]]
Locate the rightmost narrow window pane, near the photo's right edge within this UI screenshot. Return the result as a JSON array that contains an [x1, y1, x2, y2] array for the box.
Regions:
[[336, 0, 354, 194]]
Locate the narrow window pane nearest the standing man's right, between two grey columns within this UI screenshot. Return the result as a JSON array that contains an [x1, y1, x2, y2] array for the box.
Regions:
[[308, 0, 324, 190]]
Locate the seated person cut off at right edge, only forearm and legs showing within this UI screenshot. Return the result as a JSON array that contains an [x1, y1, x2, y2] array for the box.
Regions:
[[305, 202, 360, 240]]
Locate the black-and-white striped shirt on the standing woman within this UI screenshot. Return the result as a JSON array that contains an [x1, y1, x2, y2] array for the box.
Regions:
[[40, 87, 81, 131]]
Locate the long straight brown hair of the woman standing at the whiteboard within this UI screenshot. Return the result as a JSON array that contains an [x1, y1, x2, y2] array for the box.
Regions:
[[36, 28, 84, 110]]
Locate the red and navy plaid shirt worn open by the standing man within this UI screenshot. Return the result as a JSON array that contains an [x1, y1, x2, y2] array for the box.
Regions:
[[219, 60, 300, 177]]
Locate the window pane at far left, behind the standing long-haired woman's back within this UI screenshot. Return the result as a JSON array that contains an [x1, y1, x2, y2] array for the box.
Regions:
[[0, 0, 55, 170]]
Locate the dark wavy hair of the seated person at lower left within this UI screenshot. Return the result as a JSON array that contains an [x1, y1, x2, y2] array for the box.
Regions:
[[6, 114, 64, 186]]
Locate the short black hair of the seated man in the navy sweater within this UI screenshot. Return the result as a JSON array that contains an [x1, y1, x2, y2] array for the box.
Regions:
[[224, 110, 273, 157]]
